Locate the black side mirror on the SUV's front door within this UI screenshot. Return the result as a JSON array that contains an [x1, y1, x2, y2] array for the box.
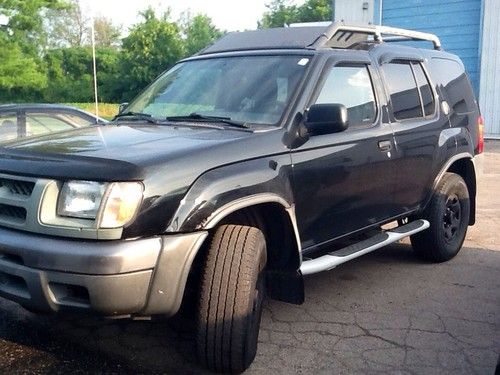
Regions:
[[304, 103, 349, 135]]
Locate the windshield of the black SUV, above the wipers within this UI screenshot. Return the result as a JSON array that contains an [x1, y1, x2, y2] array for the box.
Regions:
[[125, 56, 309, 125]]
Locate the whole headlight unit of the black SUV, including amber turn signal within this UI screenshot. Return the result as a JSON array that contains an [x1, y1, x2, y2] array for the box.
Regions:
[[57, 181, 143, 228]]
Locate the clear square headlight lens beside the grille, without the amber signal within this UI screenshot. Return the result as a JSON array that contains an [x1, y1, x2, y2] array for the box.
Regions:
[[57, 181, 106, 219]]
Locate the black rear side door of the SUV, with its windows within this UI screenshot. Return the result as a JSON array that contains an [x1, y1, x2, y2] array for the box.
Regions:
[[381, 60, 455, 213]]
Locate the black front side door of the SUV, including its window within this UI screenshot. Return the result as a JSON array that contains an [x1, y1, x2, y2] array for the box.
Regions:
[[291, 63, 393, 251]]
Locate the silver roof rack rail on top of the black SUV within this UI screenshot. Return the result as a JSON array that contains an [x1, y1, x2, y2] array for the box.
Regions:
[[310, 22, 441, 50]]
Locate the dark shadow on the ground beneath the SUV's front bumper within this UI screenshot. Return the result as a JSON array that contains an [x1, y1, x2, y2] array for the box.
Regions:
[[0, 302, 204, 374]]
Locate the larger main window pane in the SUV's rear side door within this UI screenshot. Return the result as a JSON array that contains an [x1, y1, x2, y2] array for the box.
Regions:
[[382, 63, 422, 120]]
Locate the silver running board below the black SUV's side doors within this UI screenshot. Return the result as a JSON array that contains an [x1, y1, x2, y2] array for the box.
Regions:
[[300, 219, 430, 275]]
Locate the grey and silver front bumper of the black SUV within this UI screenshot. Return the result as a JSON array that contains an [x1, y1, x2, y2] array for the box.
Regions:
[[0, 228, 207, 316]]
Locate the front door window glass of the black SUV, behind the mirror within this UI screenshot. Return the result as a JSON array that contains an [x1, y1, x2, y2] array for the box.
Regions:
[[316, 66, 376, 127]]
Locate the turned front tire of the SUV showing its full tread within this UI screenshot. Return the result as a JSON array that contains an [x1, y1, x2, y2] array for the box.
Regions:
[[197, 225, 267, 373]]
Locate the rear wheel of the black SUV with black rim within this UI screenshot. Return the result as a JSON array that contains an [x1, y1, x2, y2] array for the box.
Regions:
[[411, 172, 470, 262]]
